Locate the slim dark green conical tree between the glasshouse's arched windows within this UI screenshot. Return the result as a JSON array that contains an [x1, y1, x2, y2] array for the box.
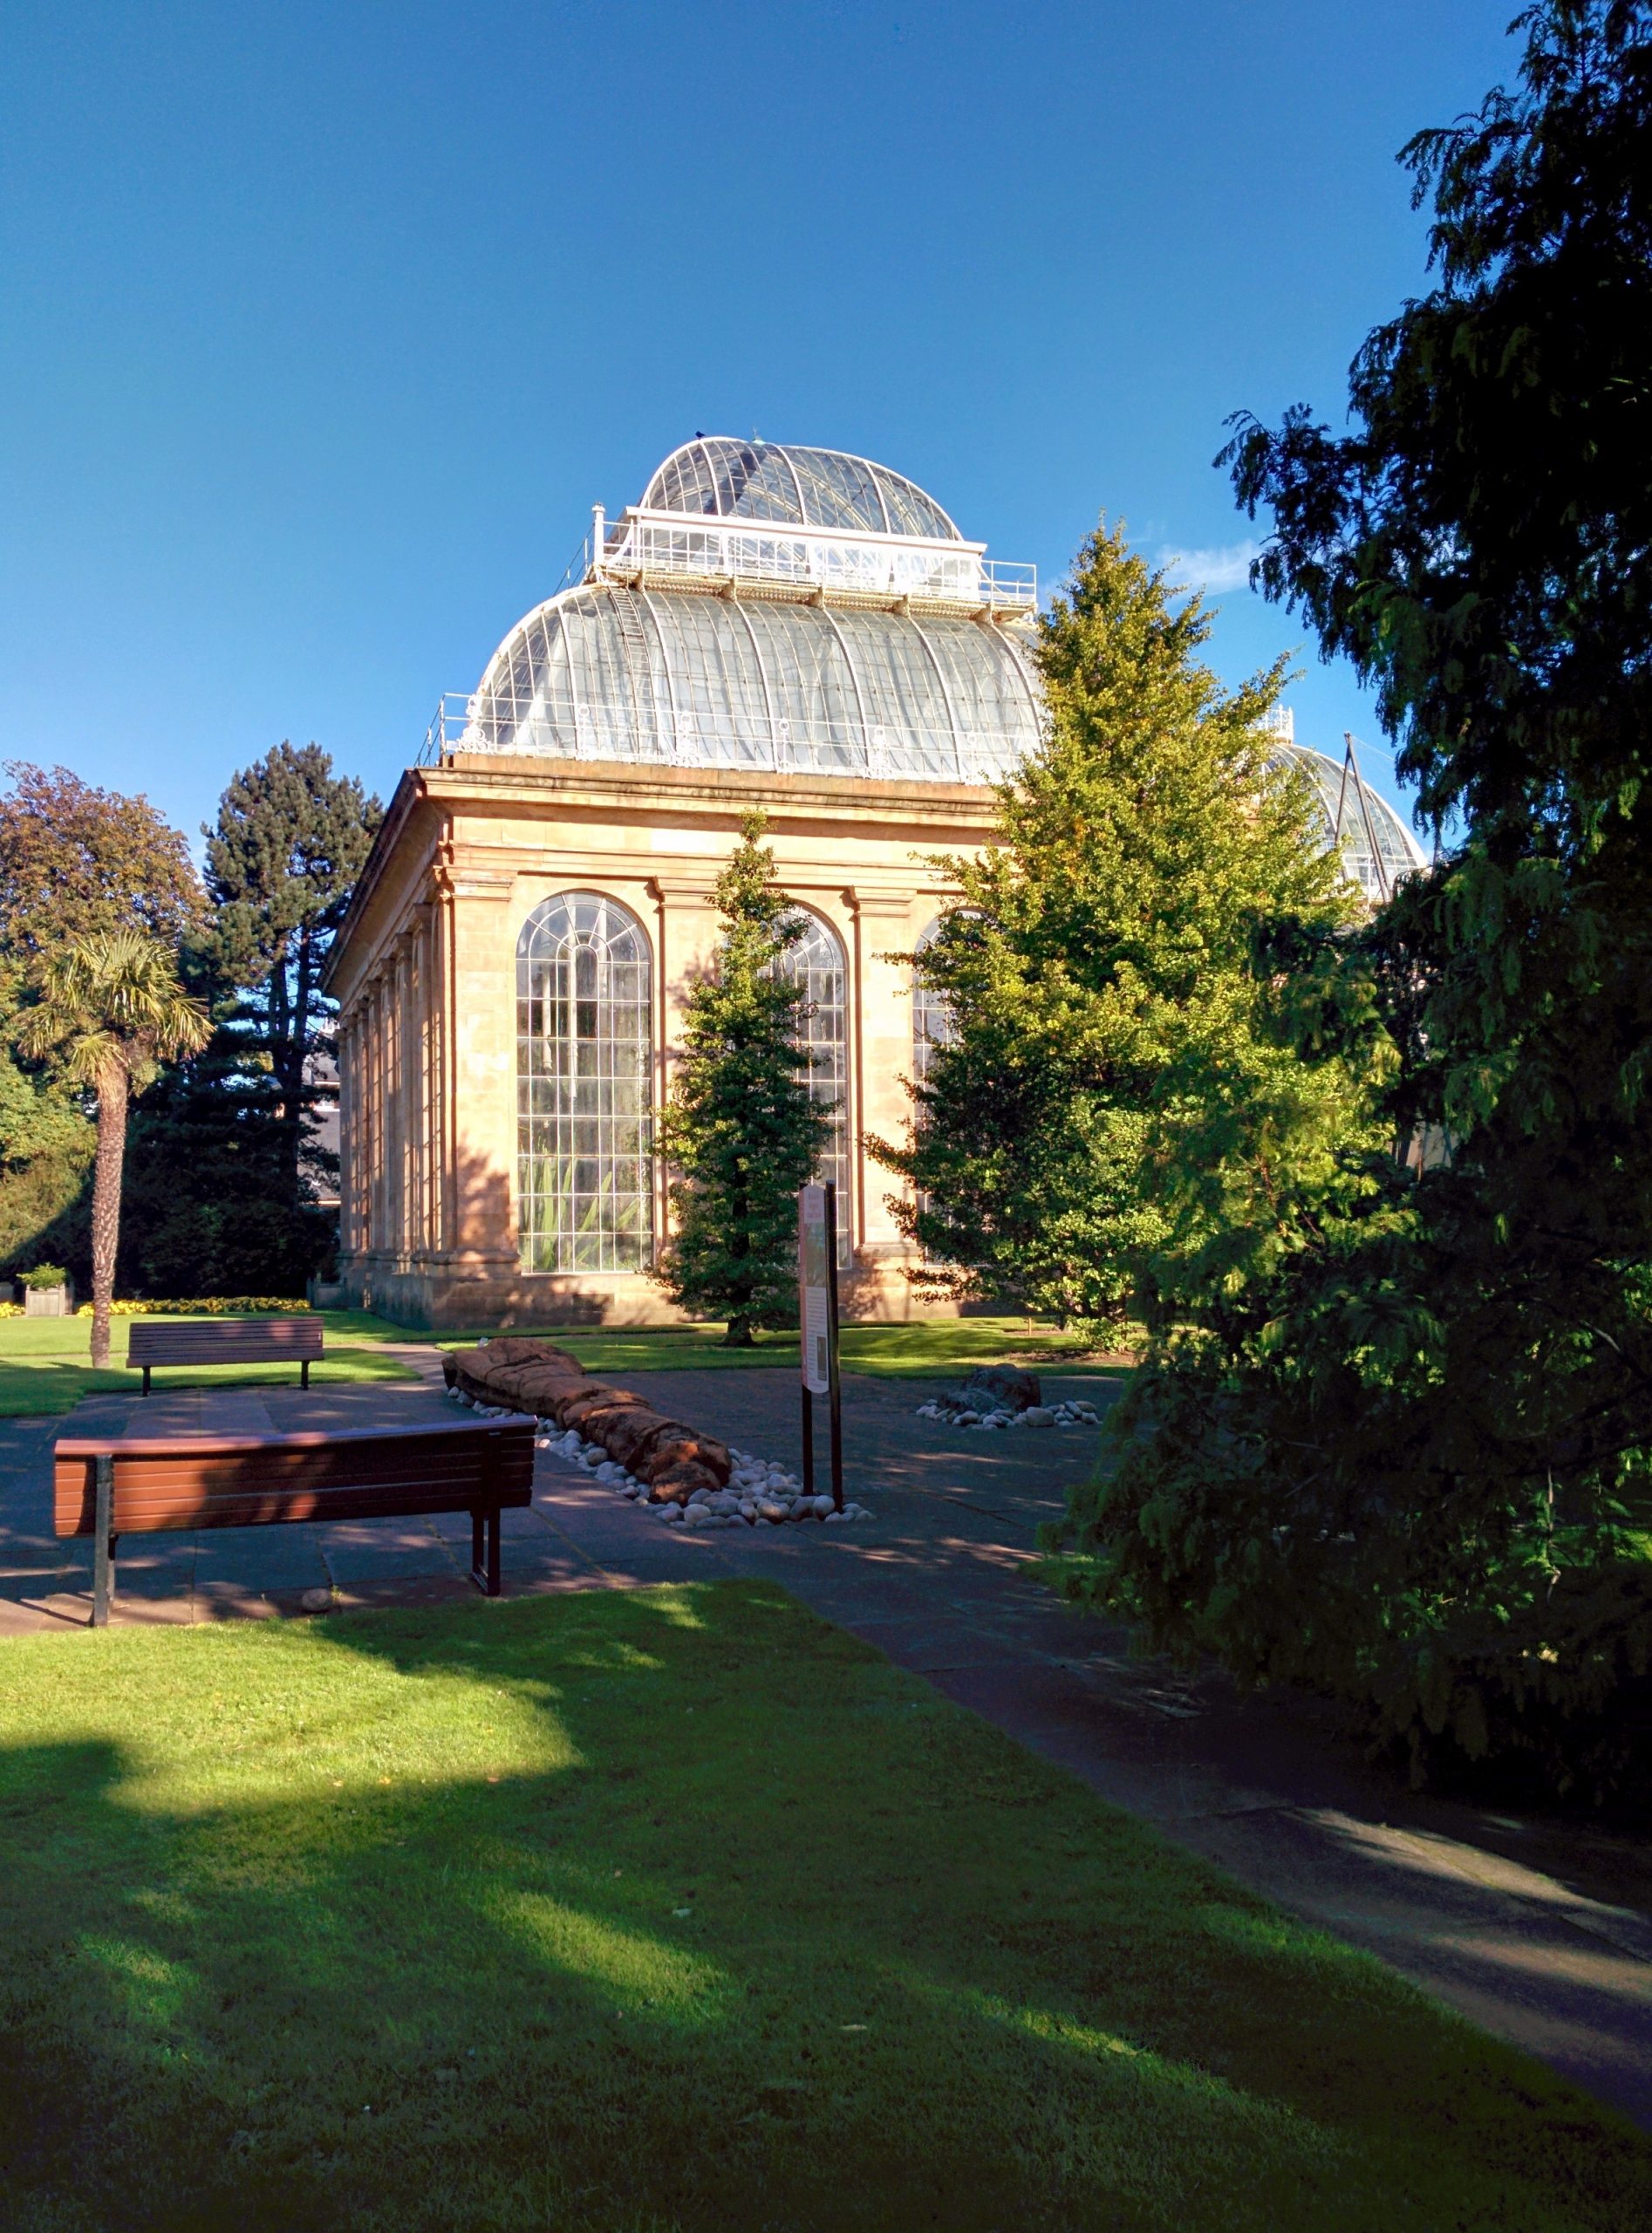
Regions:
[[656, 815, 830, 1349]]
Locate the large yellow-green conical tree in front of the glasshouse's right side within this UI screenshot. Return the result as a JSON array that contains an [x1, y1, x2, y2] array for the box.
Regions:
[[870, 522, 1350, 1322]]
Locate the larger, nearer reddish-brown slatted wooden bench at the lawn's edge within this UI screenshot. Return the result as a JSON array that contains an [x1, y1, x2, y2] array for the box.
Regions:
[[53, 1418, 538, 1628]]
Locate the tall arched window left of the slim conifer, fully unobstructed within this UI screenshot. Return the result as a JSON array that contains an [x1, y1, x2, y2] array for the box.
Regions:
[[515, 891, 654, 1271]]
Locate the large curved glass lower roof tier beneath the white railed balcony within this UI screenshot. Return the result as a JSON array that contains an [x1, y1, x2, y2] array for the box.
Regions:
[[460, 583, 1042, 784]]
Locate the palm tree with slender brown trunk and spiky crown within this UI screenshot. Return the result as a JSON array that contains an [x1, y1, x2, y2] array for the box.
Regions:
[[17, 932, 212, 1364]]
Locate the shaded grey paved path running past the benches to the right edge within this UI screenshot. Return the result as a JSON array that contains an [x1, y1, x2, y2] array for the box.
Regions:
[[0, 1344, 1652, 2128]]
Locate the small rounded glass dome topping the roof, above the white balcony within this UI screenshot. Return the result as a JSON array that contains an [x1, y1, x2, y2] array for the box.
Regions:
[[641, 435, 962, 543]]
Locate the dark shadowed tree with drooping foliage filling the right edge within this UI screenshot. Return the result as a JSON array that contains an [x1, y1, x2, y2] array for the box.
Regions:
[[1054, 0, 1652, 1799]]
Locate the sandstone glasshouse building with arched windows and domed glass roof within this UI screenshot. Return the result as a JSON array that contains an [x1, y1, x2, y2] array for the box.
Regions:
[[328, 438, 1416, 1327]]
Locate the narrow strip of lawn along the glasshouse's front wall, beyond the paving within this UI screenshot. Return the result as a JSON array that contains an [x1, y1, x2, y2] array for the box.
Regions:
[[433, 1317, 1118, 1380]]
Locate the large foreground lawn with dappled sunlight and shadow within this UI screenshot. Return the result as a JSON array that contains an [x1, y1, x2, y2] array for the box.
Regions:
[[0, 1583, 1652, 2233]]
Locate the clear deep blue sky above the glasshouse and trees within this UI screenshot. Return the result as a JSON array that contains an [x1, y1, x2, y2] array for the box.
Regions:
[[0, 0, 1516, 833]]
